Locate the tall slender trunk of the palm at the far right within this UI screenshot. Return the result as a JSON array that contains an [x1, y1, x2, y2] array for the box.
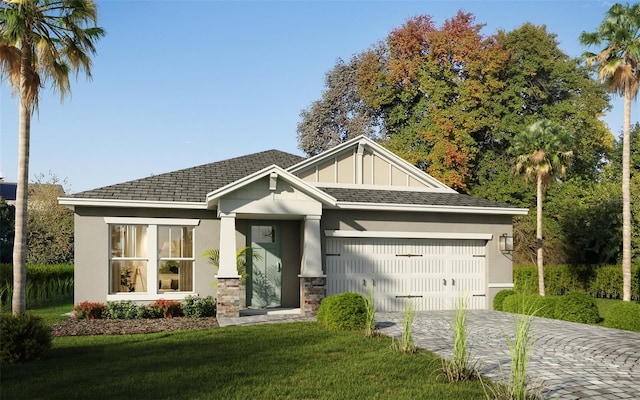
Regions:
[[622, 90, 631, 301]]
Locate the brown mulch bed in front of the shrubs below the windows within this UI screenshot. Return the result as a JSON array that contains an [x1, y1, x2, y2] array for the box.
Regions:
[[51, 317, 218, 336]]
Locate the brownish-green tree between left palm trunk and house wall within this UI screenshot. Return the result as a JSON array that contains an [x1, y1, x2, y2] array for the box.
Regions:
[[27, 174, 74, 264]]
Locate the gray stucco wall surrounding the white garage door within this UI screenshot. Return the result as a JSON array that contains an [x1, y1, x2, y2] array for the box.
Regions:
[[321, 210, 513, 308]]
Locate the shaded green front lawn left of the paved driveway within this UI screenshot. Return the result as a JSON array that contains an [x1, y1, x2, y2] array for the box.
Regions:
[[2, 322, 484, 400]]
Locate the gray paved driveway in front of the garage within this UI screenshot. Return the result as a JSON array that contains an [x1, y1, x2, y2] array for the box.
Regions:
[[376, 310, 640, 399]]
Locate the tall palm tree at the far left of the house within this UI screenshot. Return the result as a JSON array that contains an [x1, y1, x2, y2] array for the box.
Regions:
[[0, 0, 104, 315]]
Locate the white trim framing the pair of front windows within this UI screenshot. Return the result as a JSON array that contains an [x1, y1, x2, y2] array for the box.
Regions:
[[104, 217, 200, 301]]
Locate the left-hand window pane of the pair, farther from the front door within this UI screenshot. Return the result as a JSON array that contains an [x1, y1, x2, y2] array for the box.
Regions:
[[110, 225, 149, 293]]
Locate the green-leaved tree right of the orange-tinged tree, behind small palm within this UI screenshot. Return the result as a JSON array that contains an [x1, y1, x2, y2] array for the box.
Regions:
[[496, 23, 614, 180]]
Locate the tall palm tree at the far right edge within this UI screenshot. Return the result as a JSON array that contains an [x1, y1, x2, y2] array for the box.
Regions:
[[580, 3, 640, 301]]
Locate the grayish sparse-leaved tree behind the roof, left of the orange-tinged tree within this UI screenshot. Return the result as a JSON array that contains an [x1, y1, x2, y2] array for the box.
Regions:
[[297, 56, 381, 156]]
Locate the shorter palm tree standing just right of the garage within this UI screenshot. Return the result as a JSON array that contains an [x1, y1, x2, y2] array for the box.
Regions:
[[509, 119, 573, 296]]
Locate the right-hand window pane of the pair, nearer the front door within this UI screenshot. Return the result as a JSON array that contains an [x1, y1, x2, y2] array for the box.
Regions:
[[158, 226, 195, 293]]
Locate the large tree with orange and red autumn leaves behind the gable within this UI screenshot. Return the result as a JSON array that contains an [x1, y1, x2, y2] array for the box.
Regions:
[[358, 11, 508, 189]]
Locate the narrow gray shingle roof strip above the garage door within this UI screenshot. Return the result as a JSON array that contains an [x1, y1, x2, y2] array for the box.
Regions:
[[320, 188, 516, 208]]
